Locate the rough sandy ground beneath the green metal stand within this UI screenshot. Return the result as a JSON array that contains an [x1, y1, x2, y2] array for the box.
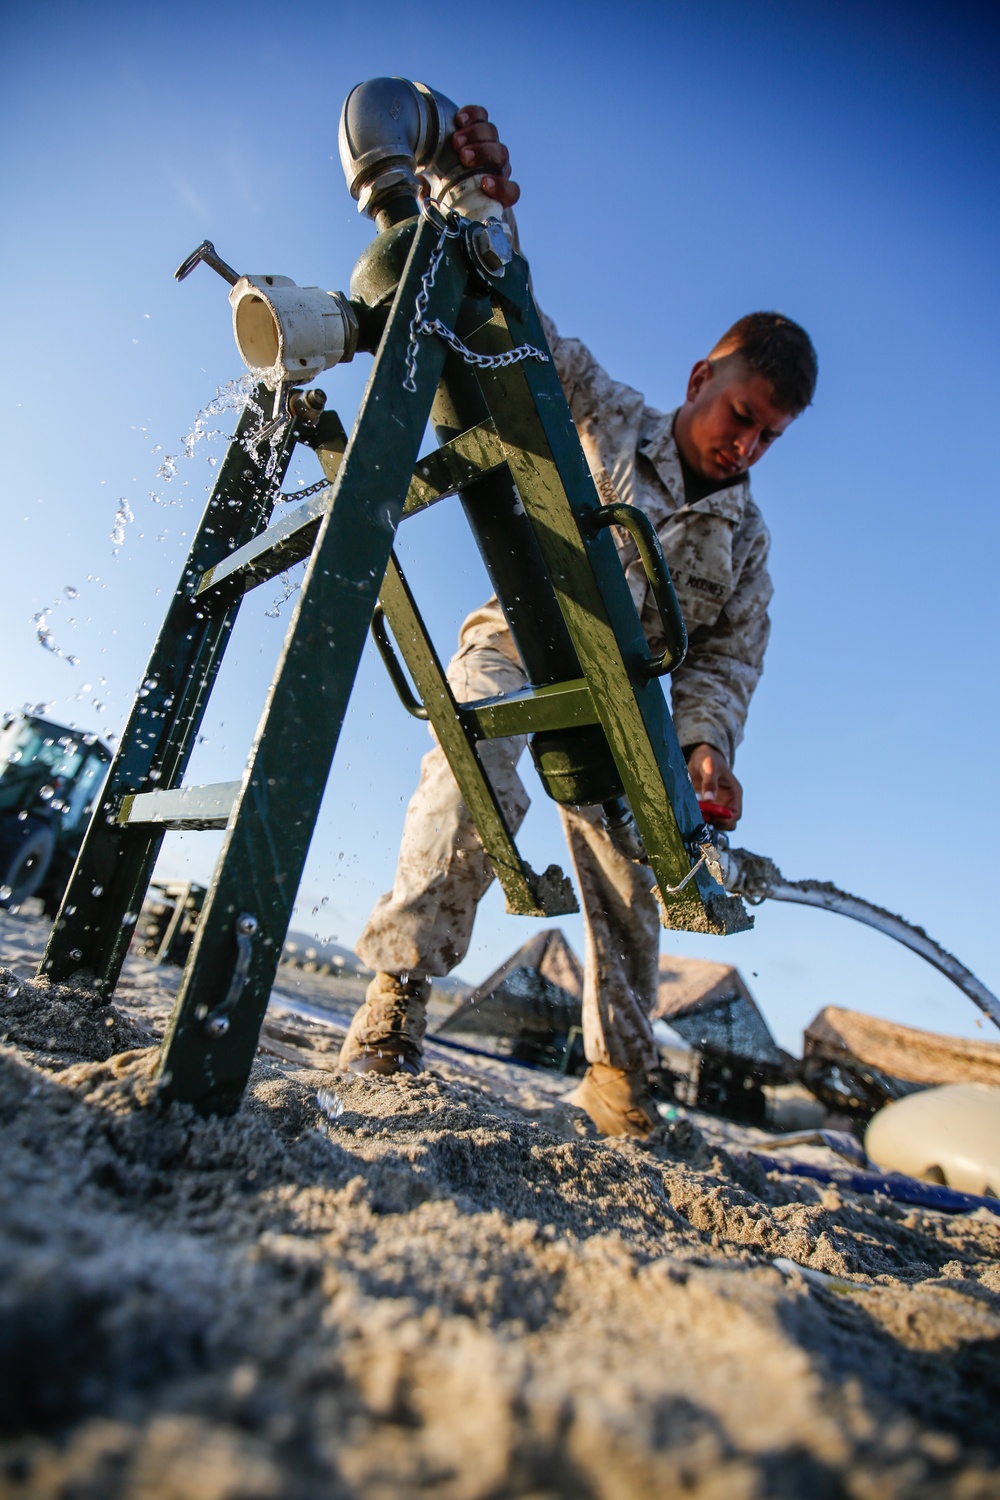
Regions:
[[0, 917, 1000, 1500]]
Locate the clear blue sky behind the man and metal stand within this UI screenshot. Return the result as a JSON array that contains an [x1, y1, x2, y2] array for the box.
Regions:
[[0, 0, 1000, 1047]]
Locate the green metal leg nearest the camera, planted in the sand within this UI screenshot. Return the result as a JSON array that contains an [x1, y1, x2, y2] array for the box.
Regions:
[[159, 214, 468, 1112]]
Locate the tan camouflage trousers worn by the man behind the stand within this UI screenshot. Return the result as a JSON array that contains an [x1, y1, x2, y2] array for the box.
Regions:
[[357, 645, 660, 1073]]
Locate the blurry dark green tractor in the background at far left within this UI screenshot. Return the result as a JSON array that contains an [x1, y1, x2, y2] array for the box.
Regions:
[[0, 714, 111, 917]]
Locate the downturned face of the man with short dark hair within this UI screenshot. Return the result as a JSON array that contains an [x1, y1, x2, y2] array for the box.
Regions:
[[673, 354, 795, 480]]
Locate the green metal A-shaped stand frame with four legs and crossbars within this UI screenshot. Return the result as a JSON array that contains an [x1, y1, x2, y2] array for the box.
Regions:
[[39, 196, 750, 1112]]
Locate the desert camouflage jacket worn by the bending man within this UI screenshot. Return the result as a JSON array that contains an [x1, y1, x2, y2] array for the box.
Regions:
[[460, 318, 772, 765]]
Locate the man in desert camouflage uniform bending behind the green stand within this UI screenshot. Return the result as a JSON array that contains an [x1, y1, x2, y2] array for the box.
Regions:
[[340, 108, 816, 1136]]
